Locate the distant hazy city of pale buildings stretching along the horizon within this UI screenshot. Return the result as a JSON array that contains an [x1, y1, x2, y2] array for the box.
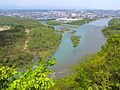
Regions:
[[0, 9, 120, 21]]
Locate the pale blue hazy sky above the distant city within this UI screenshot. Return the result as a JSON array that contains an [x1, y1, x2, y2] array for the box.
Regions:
[[0, 0, 120, 10]]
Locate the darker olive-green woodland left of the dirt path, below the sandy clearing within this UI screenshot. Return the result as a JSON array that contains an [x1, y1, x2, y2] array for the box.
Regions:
[[0, 27, 32, 66]]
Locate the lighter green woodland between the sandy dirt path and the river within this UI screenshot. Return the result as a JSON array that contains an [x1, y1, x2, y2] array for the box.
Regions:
[[28, 27, 61, 58]]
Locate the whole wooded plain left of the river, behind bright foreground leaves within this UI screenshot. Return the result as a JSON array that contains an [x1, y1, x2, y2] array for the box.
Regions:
[[0, 16, 61, 67]]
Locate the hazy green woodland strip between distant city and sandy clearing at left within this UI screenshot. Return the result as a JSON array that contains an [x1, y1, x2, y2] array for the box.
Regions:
[[0, 16, 42, 28]]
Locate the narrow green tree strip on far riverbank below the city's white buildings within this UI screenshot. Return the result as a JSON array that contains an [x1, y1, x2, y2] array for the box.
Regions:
[[67, 18, 97, 25]]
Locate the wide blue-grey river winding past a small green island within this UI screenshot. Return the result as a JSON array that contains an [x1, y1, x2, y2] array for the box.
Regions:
[[52, 19, 110, 76]]
